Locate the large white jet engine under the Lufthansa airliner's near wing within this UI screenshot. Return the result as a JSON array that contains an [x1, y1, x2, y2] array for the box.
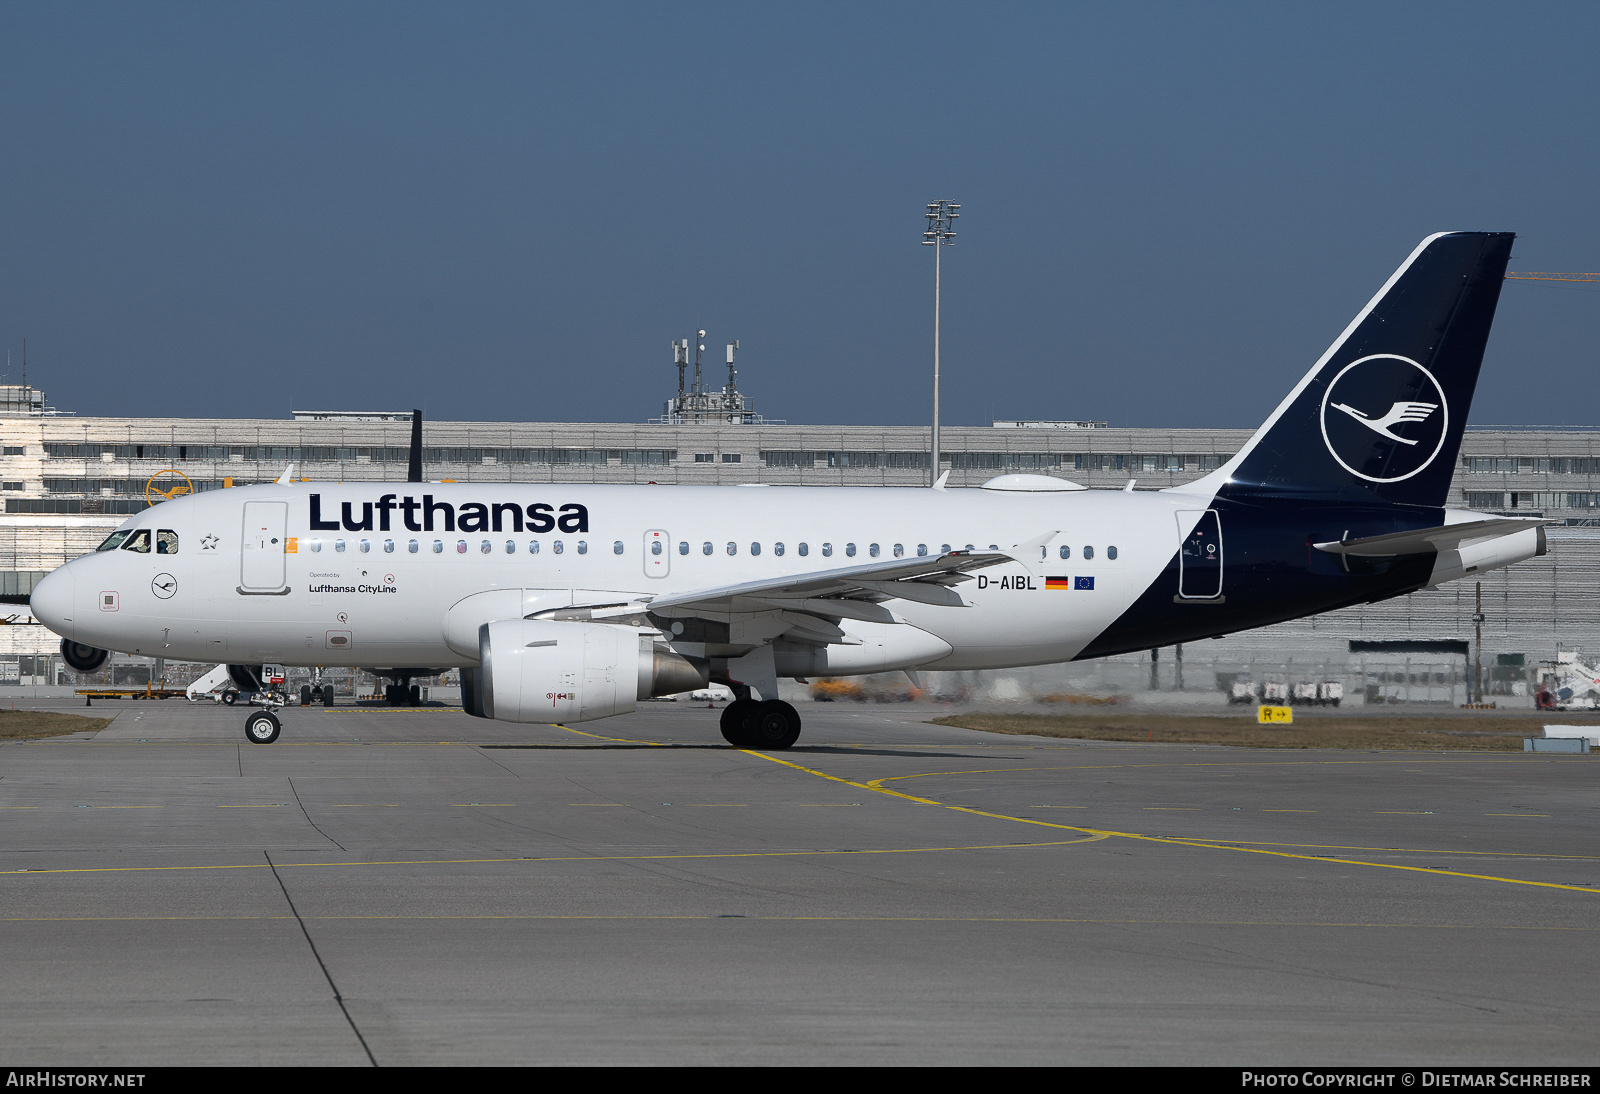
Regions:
[[462, 619, 710, 721]]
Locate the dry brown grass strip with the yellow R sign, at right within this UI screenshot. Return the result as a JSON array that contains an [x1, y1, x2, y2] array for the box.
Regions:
[[933, 712, 1595, 752]]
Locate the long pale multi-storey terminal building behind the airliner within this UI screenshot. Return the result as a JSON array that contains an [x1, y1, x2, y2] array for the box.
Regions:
[[0, 385, 1600, 702]]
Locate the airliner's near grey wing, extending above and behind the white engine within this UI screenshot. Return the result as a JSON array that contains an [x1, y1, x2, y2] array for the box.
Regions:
[[650, 550, 1011, 622]]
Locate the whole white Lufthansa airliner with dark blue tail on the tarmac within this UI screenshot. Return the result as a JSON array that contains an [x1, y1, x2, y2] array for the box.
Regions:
[[32, 232, 1546, 750]]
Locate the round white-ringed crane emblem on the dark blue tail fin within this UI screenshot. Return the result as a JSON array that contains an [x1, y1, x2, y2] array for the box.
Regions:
[[1322, 353, 1450, 483]]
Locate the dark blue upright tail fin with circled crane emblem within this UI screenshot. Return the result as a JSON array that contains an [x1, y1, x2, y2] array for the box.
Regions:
[[1186, 232, 1515, 507]]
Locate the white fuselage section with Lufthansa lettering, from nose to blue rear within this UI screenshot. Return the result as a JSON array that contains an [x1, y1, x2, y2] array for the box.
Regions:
[[34, 483, 1210, 672]]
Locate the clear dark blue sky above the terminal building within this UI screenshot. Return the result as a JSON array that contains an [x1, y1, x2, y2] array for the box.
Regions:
[[0, 2, 1600, 425]]
